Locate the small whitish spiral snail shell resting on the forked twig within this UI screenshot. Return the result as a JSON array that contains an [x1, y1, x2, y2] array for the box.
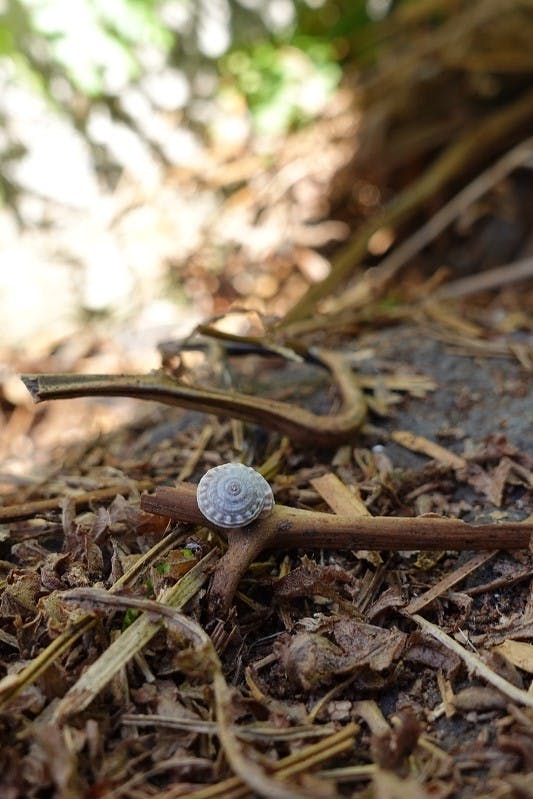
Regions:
[[196, 463, 274, 527]]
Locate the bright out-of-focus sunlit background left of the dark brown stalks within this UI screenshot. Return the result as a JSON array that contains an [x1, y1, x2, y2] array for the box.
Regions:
[[0, 0, 400, 474]]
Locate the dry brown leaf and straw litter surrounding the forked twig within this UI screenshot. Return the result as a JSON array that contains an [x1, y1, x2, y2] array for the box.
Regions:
[[0, 328, 532, 799]]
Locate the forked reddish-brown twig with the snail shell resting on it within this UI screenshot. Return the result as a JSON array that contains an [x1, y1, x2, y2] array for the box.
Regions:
[[141, 483, 533, 615]]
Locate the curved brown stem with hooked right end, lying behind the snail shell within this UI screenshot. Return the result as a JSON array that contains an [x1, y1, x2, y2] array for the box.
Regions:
[[22, 350, 366, 447]]
